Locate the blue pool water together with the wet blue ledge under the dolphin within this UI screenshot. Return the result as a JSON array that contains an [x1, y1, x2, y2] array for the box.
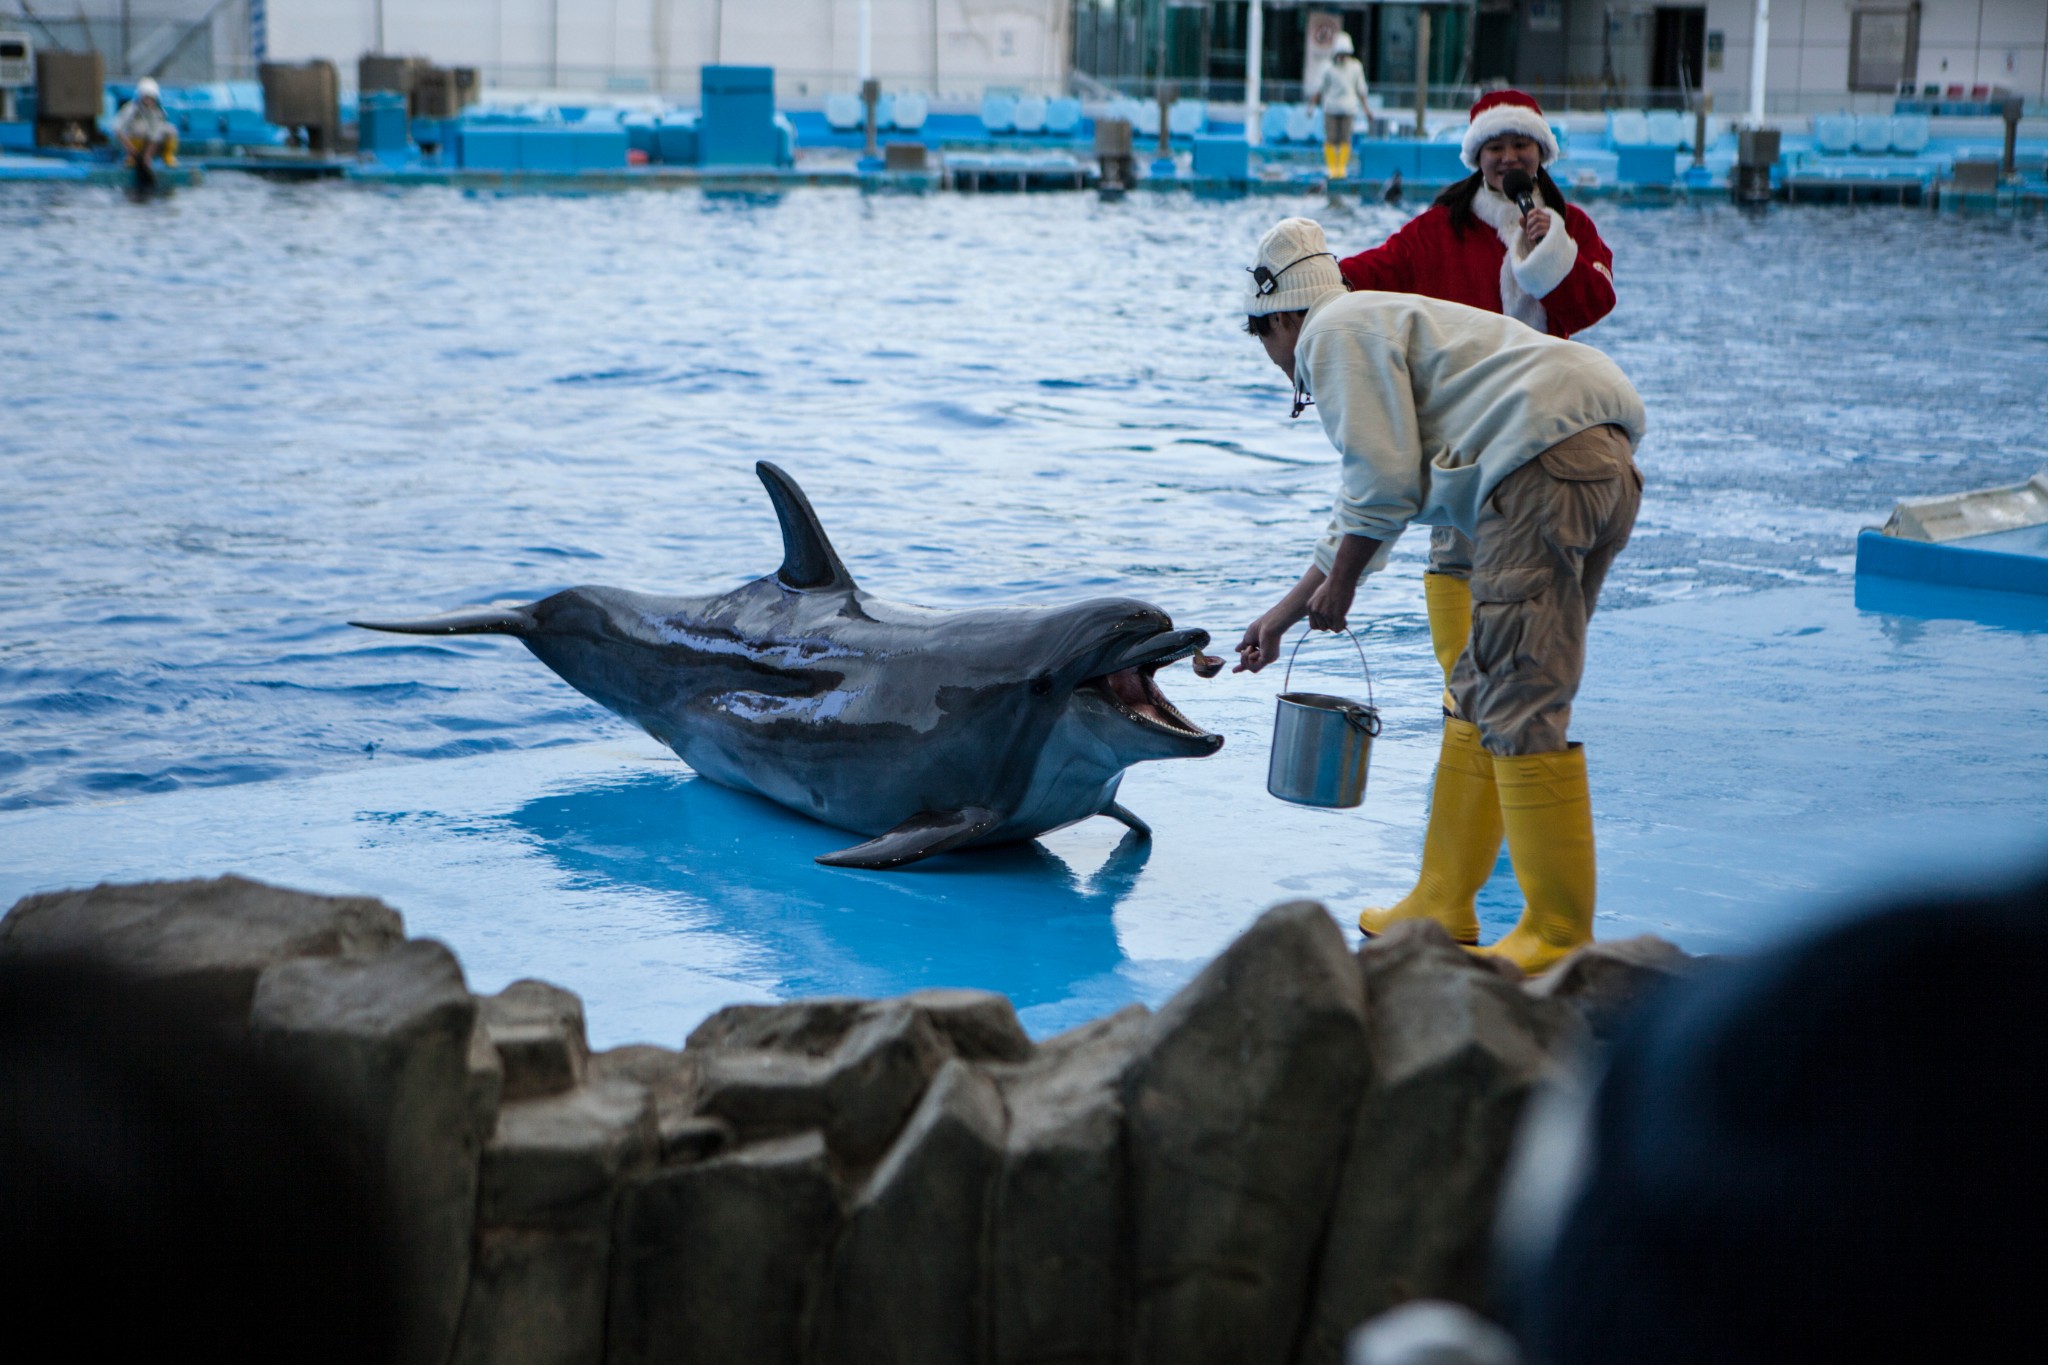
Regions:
[[0, 176, 2048, 1042]]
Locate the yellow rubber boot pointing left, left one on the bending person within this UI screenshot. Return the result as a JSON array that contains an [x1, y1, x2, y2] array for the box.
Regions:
[[1358, 716, 1501, 943]]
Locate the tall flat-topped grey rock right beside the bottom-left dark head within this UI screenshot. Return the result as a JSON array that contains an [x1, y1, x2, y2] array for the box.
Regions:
[[250, 939, 489, 1365]]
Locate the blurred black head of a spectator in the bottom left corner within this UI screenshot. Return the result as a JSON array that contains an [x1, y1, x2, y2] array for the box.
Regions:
[[0, 960, 395, 1365]]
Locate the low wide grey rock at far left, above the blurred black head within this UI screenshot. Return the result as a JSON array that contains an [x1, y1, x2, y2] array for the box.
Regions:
[[0, 876, 406, 1021]]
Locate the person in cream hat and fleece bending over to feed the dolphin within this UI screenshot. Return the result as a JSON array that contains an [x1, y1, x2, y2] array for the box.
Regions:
[[1237, 219, 1645, 972]]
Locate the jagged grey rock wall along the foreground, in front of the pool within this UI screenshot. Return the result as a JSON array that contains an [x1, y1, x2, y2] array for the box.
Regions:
[[0, 878, 1688, 1365]]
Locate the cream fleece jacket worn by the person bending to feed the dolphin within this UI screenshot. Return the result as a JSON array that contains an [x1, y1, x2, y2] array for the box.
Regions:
[[1294, 291, 1645, 573]]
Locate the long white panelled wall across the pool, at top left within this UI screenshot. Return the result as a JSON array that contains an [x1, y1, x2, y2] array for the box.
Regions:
[[266, 0, 1073, 102]]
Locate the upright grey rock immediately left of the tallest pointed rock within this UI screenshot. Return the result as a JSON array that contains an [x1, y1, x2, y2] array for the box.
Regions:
[[989, 1005, 1151, 1365]]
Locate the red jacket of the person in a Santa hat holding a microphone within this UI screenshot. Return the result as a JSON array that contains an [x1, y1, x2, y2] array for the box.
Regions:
[[1339, 205, 1614, 336]]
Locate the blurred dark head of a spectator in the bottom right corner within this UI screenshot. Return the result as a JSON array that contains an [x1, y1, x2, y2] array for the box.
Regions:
[[1509, 880, 2048, 1365]]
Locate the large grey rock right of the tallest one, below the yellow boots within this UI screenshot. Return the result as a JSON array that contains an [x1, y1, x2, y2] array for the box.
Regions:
[[1300, 921, 1579, 1363]]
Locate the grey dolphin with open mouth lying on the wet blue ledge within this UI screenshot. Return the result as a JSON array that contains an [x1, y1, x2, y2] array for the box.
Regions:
[[348, 460, 1223, 870]]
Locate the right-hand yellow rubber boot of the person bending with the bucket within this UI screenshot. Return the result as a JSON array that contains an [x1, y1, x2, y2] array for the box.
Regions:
[[1487, 745, 1595, 976]]
